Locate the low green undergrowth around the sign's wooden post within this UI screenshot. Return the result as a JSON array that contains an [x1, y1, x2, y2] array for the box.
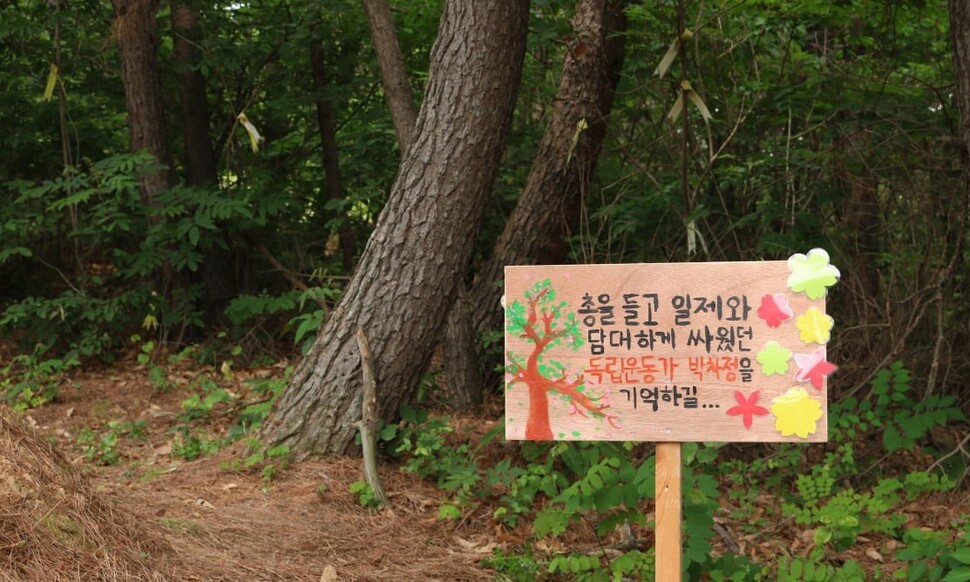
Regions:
[[374, 362, 970, 582]]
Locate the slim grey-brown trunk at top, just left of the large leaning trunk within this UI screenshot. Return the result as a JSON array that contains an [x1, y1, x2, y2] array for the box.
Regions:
[[364, 0, 418, 157]]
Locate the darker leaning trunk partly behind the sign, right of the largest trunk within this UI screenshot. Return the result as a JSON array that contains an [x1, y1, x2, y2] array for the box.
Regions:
[[445, 0, 626, 407]]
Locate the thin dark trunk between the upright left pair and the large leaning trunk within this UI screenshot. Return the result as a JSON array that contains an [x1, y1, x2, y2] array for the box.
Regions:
[[310, 40, 357, 274]]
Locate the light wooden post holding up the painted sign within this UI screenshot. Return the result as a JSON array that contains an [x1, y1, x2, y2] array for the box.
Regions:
[[654, 443, 682, 582]]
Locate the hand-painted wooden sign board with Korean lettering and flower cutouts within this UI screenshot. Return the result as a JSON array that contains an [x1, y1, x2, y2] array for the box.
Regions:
[[504, 249, 839, 442]]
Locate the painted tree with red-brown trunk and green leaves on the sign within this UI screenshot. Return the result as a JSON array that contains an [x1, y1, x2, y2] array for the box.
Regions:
[[505, 279, 619, 440]]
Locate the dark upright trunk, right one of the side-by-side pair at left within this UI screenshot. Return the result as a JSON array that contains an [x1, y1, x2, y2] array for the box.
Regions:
[[172, 1, 239, 327]]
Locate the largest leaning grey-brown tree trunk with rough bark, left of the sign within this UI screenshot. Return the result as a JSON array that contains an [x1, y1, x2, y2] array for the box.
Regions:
[[261, 0, 529, 457]]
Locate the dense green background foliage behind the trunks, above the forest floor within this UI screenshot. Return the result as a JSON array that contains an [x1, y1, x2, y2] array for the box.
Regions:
[[0, 0, 967, 388]]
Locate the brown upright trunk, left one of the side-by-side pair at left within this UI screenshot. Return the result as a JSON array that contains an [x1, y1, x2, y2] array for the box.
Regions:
[[111, 0, 171, 206]]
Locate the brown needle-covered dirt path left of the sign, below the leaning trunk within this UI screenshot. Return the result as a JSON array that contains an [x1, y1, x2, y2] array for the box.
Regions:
[[18, 365, 494, 581]]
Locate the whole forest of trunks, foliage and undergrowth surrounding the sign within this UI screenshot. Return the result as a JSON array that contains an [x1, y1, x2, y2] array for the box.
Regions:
[[0, 0, 970, 580]]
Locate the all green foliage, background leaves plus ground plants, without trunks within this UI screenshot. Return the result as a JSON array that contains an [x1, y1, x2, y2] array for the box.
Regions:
[[0, 0, 970, 580]]
